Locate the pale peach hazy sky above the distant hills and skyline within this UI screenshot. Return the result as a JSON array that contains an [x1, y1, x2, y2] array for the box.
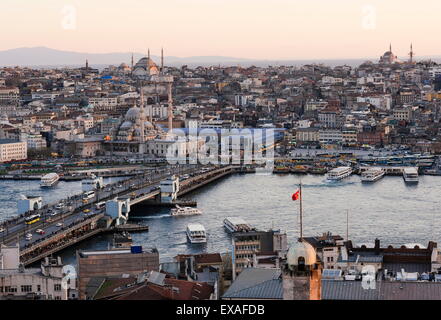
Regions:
[[0, 0, 441, 59]]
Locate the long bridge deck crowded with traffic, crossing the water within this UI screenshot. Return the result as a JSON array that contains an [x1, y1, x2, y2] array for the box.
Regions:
[[0, 166, 236, 265]]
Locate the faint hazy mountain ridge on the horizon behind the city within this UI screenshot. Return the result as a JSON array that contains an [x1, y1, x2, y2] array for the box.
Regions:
[[0, 47, 441, 67]]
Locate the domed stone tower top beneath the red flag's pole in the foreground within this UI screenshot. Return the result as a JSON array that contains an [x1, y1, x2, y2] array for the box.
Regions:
[[282, 239, 321, 300]]
